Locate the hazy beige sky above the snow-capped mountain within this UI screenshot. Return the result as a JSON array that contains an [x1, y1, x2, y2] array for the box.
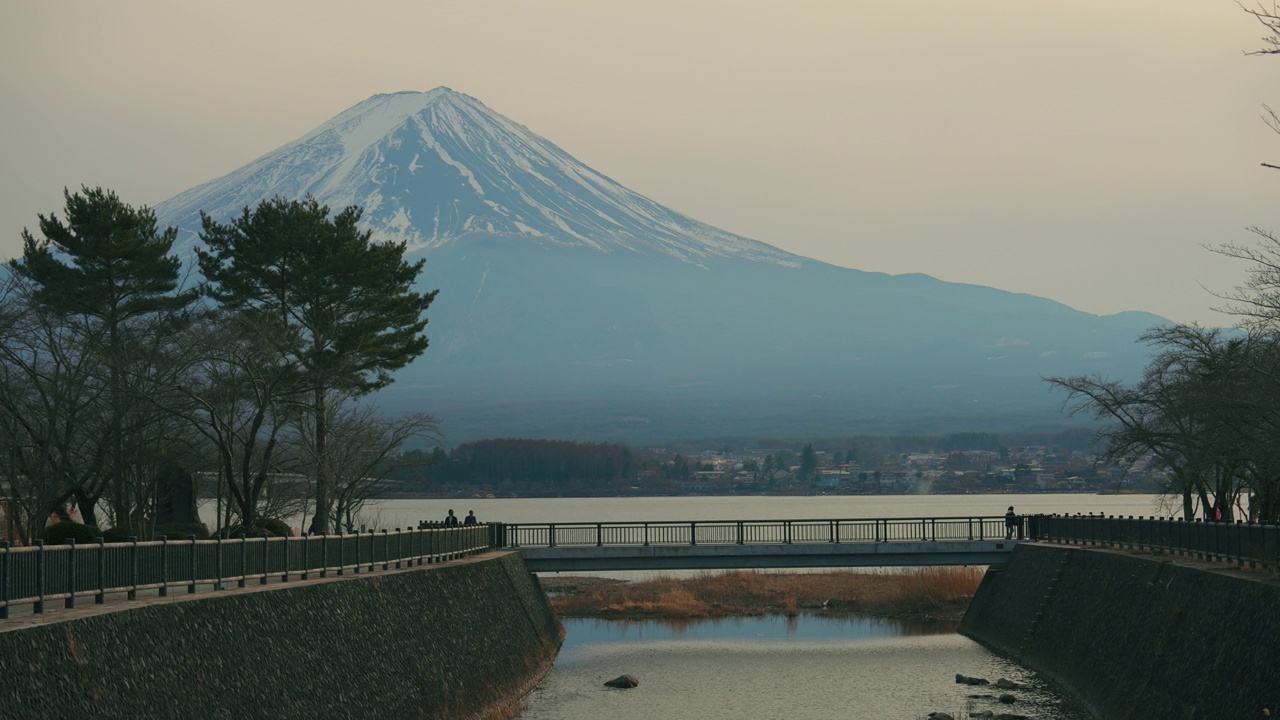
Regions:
[[0, 0, 1280, 324]]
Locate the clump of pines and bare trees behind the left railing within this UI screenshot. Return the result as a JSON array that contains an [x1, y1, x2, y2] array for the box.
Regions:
[[0, 188, 436, 537]]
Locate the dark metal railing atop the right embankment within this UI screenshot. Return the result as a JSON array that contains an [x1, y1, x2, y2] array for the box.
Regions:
[[1028, 515, 1280, 570]]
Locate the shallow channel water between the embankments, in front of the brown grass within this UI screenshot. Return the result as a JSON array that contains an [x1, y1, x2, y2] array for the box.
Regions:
[[520, 615, 1088, 720]]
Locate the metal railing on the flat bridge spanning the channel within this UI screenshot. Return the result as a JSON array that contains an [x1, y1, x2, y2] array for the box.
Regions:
[[507, 515, 1005, 548]]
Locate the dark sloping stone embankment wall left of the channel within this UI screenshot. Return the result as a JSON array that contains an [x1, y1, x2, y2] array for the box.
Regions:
[[0, 552, 563, 720]]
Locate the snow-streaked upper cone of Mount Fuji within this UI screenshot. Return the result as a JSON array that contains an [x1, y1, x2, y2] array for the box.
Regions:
[[155, 87, 812, 266]]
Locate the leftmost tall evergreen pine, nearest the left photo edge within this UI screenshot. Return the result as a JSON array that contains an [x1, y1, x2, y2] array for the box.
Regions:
[[9, 187, 198, 527]]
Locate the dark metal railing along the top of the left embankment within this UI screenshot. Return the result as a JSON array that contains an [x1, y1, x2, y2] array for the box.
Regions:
[[0, 523, 506, 620]]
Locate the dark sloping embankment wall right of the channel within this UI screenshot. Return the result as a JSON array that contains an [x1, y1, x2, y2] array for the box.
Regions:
[[960, 544, 1280, 720]]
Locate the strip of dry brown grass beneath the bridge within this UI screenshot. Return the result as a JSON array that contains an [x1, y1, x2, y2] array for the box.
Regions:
[[544, 568, 983, 618]]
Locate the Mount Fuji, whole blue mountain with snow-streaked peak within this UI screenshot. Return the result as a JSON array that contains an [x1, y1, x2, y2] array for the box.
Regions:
[[155, 87, 1165, 442]]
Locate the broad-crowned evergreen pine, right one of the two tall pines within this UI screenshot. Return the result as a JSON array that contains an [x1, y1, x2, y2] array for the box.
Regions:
[[197, 197, 438, 532]]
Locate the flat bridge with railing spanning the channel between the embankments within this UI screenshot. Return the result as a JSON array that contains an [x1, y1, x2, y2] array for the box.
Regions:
[[504, 516, 1020, 573]]
